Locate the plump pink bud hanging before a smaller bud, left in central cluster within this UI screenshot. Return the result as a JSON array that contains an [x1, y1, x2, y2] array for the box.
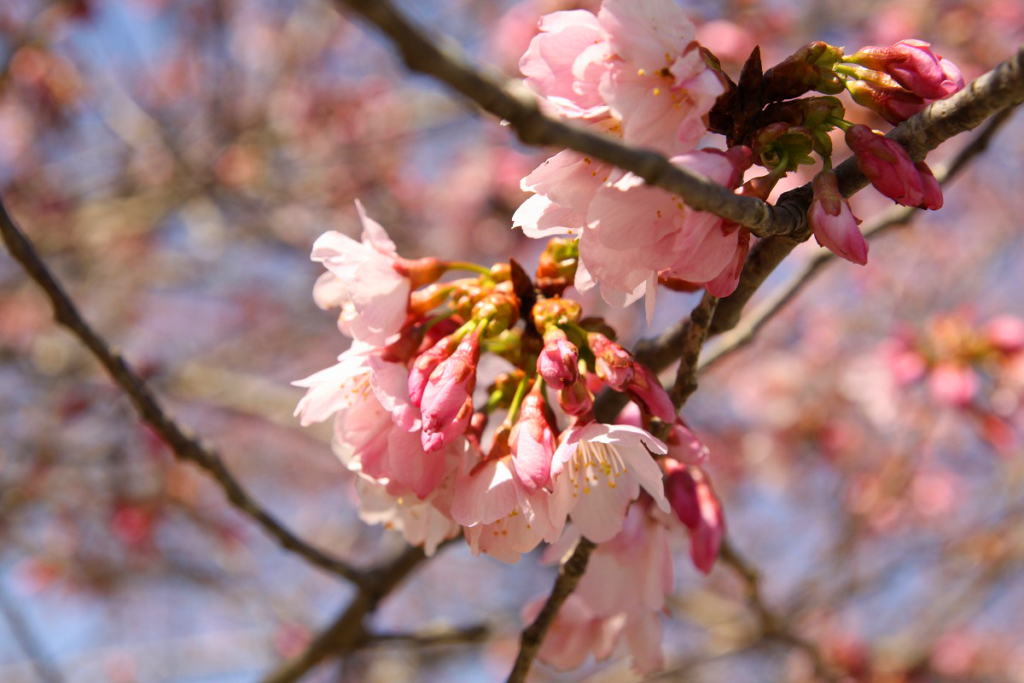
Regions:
[[420, 331, 480, 453]]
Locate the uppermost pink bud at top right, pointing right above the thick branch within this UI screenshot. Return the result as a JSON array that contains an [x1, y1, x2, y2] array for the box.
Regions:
[[844, 38, 964, 99]]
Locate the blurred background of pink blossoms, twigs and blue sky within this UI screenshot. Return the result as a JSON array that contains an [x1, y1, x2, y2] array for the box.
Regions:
[[0, 0, 1024, 683]]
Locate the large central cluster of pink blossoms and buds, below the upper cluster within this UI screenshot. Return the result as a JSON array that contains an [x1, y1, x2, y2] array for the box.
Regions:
[[296, 204, 724, 670]]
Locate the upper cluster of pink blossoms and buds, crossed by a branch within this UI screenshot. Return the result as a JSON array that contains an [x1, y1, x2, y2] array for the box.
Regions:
[[513, 0, 964, 315]]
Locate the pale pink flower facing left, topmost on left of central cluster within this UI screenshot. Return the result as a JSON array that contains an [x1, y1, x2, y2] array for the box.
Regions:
[[310, 200, 412, 346]]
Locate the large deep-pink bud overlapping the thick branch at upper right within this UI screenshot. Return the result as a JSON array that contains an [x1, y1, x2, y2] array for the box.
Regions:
[[846, 124, 925, 206]]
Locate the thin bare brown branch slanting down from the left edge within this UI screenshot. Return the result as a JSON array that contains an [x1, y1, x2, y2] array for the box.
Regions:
[[0, 200, 369, 585]]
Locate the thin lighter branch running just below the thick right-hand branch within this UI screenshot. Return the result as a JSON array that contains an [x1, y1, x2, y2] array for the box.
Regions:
[[697, 106, 1016, 372]]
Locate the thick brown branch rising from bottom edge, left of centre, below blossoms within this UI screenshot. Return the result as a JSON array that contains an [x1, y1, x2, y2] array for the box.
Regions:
[[262, 548, 436, 683]]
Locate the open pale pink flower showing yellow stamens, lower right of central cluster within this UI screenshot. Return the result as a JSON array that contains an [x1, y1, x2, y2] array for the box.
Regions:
[[551, 422, 669, 543]]
